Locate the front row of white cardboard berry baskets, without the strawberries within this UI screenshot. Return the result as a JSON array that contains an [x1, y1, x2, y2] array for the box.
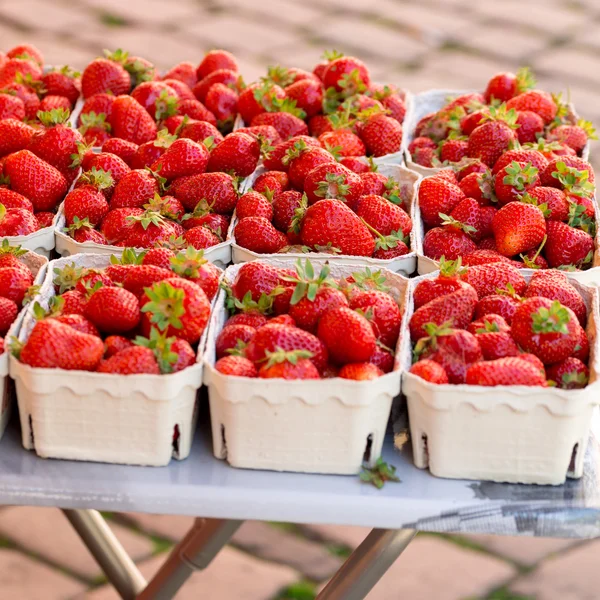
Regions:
[[0, 246, 600, 484]]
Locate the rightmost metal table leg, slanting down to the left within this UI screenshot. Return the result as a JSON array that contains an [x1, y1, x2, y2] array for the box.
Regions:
[[317, 529, 416, 600]]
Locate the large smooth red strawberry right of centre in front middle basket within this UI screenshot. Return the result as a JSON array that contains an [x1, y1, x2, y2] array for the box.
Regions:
[[318, 307, 376, 365]]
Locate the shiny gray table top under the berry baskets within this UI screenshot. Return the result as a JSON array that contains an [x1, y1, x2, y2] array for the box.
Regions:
[[0, 412, 600, 538]]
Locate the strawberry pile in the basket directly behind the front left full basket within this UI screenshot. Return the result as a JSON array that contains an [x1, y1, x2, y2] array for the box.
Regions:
[[64, 120, 270, 249]]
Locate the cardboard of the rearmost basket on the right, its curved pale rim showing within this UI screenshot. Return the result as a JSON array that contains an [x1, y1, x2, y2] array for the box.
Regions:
[[402, 89, 590, 177]]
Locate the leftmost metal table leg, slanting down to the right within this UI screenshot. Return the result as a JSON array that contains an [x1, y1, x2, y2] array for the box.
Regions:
[[63, 509, 146, 600]]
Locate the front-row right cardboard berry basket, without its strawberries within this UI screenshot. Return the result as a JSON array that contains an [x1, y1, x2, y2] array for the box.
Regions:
[[400, 269, 600, 485]]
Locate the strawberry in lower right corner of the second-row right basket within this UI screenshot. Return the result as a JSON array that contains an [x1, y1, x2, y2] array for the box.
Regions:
[[544, 221, 594, 269]]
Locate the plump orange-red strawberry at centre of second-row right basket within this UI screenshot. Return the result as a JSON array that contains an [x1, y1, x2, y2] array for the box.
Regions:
[[492, 202, 546, 256]]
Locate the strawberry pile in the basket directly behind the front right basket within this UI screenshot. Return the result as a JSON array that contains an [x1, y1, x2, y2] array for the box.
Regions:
[[419, 152, 597, 270]]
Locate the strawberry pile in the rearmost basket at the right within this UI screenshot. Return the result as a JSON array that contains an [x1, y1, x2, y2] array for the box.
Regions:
[[408, 68, 596, 168]]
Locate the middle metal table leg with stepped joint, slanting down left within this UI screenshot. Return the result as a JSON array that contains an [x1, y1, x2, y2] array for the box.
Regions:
[[137, 519, 243, 600]]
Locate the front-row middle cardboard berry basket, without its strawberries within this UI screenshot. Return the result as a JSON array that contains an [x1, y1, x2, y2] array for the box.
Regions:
[[204, 258, 408, 475]]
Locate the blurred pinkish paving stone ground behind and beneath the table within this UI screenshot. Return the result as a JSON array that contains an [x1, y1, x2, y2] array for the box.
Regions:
[[0, 0, 600, 600]]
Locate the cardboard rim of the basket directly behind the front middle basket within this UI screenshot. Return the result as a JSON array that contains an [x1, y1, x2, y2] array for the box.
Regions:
[[231, 164, 421, 276]]
